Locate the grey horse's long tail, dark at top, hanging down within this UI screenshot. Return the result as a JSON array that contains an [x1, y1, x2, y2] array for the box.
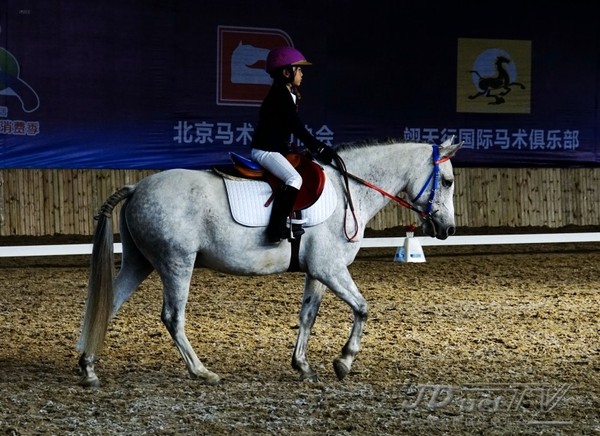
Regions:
[[77, 185, 135, 356]]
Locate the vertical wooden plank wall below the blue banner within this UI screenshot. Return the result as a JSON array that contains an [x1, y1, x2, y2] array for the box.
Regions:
[[0, 168, 600, 236]]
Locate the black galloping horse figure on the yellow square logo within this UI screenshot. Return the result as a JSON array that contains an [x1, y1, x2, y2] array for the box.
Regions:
[[469, 55, 525, 104]]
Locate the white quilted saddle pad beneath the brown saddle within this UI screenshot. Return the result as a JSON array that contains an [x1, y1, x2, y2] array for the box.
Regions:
[[223, 178, 337, 227]]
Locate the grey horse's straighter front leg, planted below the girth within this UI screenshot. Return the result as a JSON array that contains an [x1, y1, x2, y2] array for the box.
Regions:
[[292, 274, 327, 382]]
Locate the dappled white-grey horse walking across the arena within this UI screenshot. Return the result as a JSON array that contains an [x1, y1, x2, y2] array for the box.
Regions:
[[78, 138, 462, 386]]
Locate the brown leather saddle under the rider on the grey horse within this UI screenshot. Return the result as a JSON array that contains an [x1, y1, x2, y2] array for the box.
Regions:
[[216, 152, 325, 210]]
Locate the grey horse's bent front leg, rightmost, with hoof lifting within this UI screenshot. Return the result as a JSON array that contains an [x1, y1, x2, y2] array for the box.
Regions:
[[327, 268, 368, 380]]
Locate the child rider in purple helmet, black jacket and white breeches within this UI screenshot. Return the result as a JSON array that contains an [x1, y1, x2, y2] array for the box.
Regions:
[[251, 47, 335, 243]]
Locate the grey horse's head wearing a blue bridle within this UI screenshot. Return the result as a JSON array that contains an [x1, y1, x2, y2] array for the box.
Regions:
[[413, 137, 462, 239]]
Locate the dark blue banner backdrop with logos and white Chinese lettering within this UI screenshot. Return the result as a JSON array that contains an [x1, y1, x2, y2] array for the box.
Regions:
[[0, 0, 600, 169]]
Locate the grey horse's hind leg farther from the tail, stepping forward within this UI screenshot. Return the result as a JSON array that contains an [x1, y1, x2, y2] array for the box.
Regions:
[[157, 256, 220, 385]]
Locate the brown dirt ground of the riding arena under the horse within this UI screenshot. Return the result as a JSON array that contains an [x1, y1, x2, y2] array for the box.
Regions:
[[0, 230, 600, 435]]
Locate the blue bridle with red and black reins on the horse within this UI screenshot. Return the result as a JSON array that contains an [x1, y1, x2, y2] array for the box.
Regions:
[[334, 144, 450, 241]]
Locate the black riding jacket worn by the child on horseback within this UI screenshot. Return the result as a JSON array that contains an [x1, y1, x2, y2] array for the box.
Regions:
[[251, 82, 325, 155]]
